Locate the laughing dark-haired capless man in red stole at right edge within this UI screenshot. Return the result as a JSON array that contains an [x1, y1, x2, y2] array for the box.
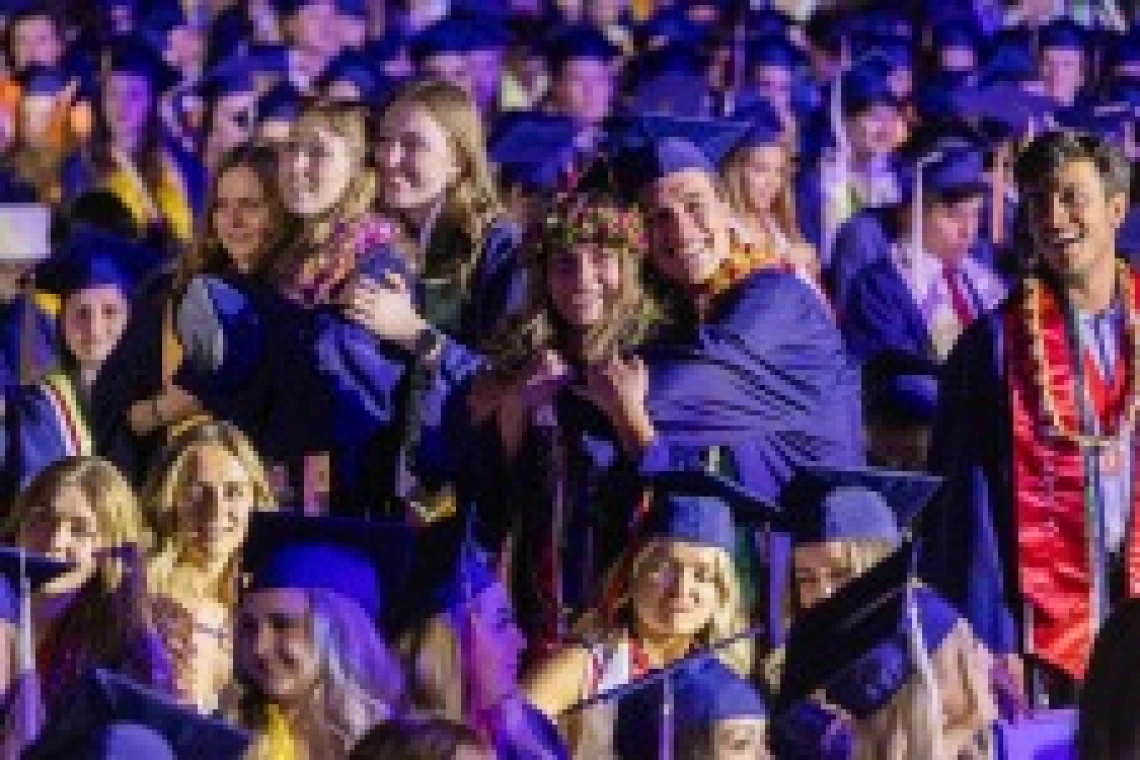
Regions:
[[923, 132, 1140, 704]]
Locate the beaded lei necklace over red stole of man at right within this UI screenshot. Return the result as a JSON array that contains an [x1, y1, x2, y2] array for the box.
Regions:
[[1025, 262, 1140, 449]]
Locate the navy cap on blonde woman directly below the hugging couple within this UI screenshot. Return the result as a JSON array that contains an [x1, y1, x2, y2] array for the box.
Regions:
[[638, 471, 780, 553]]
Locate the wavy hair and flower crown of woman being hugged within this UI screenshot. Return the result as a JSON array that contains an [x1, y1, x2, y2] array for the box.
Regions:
[[488, 193, 660, 377]]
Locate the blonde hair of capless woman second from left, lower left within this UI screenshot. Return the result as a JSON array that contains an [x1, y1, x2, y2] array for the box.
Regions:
[[143, 420, 277, 606]]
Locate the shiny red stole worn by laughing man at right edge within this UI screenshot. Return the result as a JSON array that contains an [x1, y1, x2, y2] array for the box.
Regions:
[[1003, 274, 1140, 680]]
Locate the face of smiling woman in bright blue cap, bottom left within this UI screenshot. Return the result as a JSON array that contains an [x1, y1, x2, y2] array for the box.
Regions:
[[235, 589, 320, 705]]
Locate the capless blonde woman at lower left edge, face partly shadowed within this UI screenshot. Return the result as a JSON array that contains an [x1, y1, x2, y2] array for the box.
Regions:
[[5, 457, 180, 717]]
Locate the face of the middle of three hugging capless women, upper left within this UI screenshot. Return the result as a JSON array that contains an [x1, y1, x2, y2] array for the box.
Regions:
[[279, 121, 361, 216]]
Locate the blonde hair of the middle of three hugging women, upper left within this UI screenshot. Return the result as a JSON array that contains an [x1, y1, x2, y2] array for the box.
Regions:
[[268, 99, 376, 280]]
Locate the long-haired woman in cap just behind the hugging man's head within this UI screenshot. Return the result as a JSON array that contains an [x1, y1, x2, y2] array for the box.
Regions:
[[720, 106, 822, 303]]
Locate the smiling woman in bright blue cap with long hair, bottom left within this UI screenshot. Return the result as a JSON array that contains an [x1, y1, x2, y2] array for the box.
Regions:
[[227, 513, 407, 760]]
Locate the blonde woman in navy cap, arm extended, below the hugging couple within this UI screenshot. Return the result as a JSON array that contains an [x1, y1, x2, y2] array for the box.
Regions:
[[524, 472, 763, 758]]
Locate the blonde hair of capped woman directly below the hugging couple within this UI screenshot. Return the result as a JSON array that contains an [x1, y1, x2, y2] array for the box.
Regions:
[[576, 538, 752, 678]]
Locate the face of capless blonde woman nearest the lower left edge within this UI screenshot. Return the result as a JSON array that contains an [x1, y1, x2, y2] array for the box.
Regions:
[[16, 485, 101, 594]]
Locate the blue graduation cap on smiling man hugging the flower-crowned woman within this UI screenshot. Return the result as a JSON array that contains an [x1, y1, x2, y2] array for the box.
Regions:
[[579, 114, 749, 197]]
